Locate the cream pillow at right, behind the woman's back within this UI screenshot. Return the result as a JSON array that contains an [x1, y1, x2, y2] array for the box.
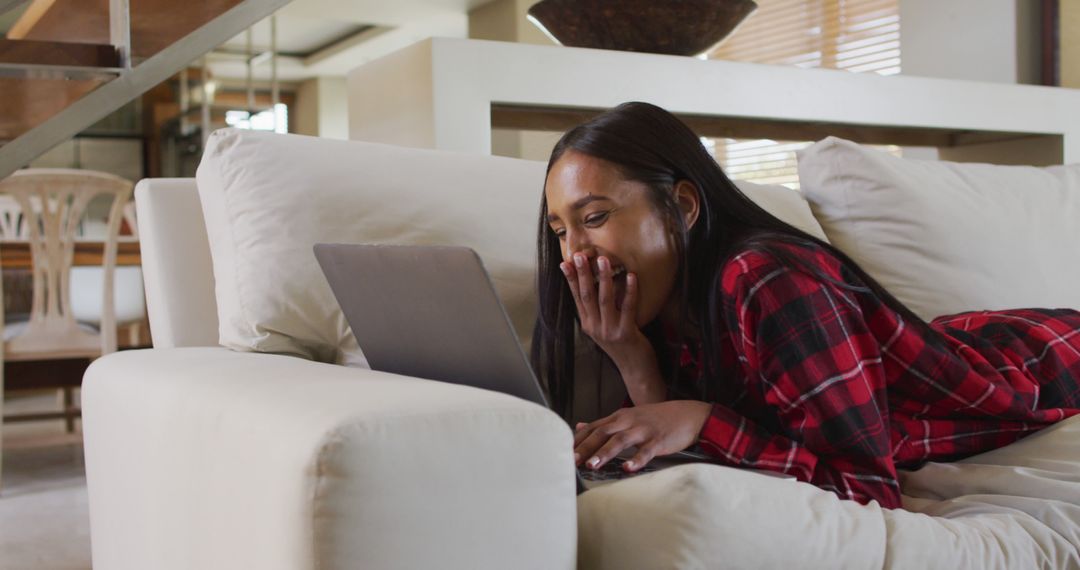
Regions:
[[798, 137, 1080, 320]]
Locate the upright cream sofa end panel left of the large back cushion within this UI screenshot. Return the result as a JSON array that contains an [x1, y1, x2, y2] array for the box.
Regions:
[[135, 178, 217, 349]]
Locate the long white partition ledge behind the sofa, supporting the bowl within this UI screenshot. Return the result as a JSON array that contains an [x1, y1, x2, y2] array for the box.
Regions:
[[349, 38, 1080, 164]]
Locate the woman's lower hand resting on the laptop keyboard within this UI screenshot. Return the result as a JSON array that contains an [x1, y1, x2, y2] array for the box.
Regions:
[[573, 399, 713, 471]]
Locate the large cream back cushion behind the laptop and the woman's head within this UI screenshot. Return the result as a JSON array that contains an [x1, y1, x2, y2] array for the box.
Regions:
[[197, 130, 823, 364]]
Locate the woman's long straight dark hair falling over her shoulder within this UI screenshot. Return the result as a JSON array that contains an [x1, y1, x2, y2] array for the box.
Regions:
[[531, 103, 933, 418]]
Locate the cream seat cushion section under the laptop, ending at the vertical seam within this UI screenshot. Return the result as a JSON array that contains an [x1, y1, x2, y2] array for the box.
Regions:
[[578, 464, 886, 570]]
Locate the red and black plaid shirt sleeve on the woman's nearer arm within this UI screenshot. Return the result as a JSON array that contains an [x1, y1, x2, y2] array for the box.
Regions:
[[701, 253, 900, 508]]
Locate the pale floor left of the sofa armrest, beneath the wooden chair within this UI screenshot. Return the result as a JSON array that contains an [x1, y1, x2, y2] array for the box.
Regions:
[[0, 394, 91, 570]]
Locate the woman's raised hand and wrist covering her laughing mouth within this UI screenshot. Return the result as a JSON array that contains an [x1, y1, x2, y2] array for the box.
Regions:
[[559, 253, 666, 405]]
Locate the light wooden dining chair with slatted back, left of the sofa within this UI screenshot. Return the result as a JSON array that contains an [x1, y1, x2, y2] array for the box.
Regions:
[[0, 168, 133, 490]]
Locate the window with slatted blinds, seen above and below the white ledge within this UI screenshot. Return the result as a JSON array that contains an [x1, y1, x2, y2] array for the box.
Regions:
[[706, 0, 900, 189]]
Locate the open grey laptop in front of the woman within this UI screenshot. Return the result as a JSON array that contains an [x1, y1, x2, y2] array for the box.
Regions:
[[314, 244, 794, 493]]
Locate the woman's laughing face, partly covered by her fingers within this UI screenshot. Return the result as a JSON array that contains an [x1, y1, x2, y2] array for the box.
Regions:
[[544, 150, 678, 327]]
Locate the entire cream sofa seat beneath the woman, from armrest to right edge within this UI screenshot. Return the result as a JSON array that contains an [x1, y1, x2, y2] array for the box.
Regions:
[[578, 416, 1080, 570]]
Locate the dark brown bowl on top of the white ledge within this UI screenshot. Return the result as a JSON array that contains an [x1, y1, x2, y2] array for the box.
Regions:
[[528, 0, 757, 55]]
